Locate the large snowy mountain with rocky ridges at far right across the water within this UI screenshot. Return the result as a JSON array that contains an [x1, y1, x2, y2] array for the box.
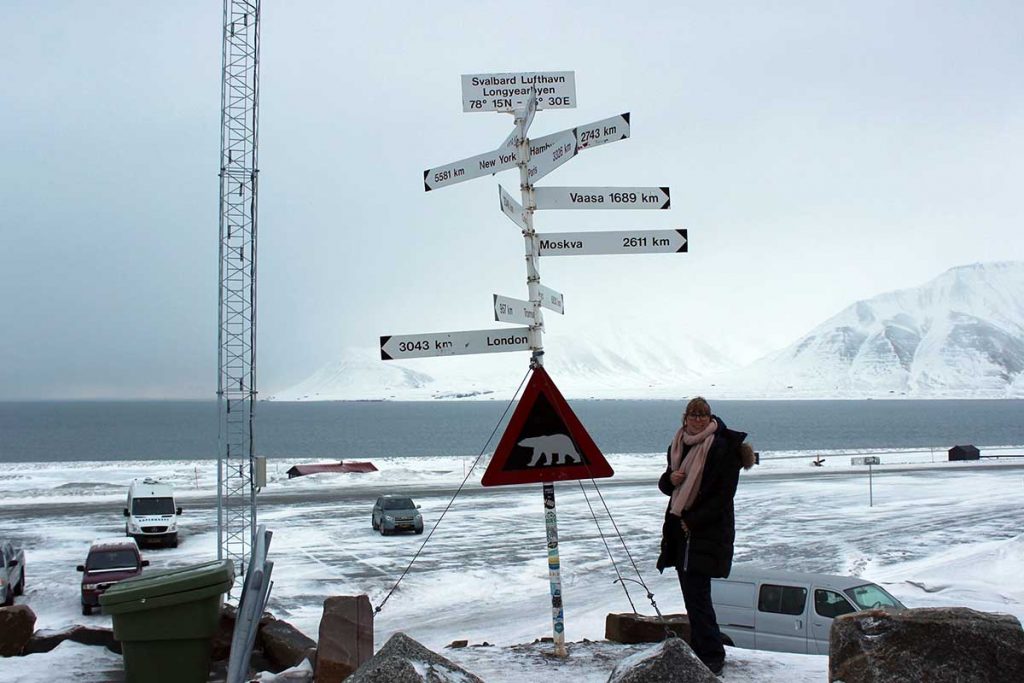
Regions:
[[716, 262, 1024, 398]]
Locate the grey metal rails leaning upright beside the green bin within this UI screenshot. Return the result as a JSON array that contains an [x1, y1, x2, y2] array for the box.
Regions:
[[226, 524, 273, 683]]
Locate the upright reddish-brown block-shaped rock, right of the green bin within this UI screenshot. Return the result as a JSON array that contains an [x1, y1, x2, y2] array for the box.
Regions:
[[316, 595, 374, 683]]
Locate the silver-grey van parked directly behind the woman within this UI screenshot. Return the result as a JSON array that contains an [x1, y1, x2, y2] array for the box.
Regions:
[[711, 567, 904, 654]]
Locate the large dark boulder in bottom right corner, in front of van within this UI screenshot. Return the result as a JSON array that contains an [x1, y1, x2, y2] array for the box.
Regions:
[[828, 607, 1024, 683]]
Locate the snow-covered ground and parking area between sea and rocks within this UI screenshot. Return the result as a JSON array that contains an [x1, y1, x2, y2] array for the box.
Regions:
[[0, 447, 1024, 682]]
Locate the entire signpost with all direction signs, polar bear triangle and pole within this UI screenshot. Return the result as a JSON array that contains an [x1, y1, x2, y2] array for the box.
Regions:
[[395, 72, 688, 656]]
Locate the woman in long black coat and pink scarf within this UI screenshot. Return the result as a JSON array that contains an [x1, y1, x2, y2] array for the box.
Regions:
[[657, 396, 754, 674]]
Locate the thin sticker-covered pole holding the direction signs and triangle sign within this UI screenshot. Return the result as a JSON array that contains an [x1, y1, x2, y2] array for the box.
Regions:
[[515, 93, 566, 657]]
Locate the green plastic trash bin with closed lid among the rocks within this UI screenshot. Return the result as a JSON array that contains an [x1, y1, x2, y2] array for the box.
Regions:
[[99, 560, 234, 683]]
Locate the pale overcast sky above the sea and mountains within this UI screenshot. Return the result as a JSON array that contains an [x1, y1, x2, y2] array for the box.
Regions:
[[0, 0, 1024, 398]]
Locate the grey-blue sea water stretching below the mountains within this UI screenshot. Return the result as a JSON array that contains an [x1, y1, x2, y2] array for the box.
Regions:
[[0, 399, 1024, 462]]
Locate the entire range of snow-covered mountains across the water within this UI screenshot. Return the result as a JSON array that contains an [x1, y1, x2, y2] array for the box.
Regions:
[[272, 262, 1024, 400]]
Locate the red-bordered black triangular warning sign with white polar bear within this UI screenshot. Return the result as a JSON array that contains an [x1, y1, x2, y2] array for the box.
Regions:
[[480, 368, 614, 486]]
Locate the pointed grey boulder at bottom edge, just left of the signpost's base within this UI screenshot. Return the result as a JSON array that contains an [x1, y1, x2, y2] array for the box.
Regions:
[[345, 633, 483, 683]]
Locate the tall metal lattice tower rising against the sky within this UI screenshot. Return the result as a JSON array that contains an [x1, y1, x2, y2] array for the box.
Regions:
[[217, 0, 260, 577]]
